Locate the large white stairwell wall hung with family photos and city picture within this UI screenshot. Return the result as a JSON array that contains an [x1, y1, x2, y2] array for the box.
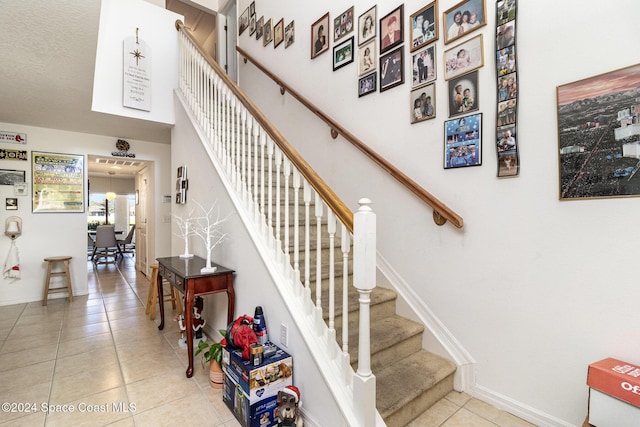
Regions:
[[238, 0, 640, 425]]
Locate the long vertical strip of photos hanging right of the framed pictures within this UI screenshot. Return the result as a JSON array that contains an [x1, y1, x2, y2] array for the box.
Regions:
[[496, 0, 520, 177]]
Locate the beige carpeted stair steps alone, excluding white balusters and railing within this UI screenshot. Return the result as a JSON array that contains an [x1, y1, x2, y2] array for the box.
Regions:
[[280, 180, 456, 427]]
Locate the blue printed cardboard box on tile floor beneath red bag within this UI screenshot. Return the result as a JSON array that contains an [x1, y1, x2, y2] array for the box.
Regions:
[[222, 345, 293, 427]]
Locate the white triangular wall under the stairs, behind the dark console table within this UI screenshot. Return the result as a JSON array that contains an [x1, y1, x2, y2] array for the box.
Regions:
[[171, 96, 344, 426]]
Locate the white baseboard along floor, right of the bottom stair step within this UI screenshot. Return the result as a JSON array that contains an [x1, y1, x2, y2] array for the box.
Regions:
[[467, 385, 575, 427]]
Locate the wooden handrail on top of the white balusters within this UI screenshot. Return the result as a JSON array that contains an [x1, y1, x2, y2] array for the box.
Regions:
[[176, 20, 353, 233]]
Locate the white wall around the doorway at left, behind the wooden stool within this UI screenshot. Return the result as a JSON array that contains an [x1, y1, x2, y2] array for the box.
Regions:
[[0, 123, 171, 305]]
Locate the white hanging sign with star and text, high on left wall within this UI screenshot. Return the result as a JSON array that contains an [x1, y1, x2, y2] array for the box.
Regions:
[[122, 28, 151, 111]]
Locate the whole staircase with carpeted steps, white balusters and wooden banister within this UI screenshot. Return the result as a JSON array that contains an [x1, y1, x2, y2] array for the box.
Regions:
[[175, 25, 456, 427]]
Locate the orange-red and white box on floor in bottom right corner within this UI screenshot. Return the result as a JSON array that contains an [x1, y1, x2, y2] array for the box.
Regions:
[[587, 358, 640, 427]]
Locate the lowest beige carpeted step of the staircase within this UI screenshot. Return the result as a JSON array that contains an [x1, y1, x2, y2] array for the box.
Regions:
[[376, 350, 456, 427]]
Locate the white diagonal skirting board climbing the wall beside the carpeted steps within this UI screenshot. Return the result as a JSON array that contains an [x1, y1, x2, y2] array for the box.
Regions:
[[376, 253, 476, 391]]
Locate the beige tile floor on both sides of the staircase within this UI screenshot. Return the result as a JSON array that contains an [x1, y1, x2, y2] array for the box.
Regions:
[[0, 257, 531, 427]]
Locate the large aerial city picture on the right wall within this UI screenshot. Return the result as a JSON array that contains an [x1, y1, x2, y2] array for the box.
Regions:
[[556, 64, 640, 200]]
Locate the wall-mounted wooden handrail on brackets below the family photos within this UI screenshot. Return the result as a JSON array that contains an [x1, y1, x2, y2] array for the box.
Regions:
[[236, 46, 464, 228]]
